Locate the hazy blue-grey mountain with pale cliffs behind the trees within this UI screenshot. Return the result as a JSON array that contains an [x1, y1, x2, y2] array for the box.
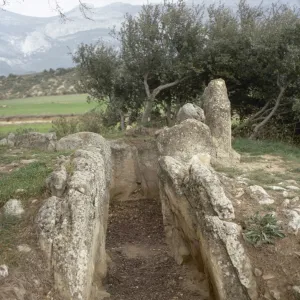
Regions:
[[0, 0, 300, 75]]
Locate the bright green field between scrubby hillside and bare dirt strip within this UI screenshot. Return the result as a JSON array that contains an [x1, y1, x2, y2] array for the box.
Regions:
[[0, 94, 97, 117]]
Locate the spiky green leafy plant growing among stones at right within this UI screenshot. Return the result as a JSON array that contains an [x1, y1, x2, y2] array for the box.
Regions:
[[244, 213, 285, 246]]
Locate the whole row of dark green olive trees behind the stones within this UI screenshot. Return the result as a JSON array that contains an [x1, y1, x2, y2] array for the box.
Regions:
[[74, 0, 300, 140]]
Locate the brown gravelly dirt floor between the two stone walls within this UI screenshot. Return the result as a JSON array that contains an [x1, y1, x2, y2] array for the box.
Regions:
[[106, 200, 210, 300]]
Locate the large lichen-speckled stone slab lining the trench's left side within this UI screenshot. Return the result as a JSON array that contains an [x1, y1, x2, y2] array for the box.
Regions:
[[36, 138, 111, 300]]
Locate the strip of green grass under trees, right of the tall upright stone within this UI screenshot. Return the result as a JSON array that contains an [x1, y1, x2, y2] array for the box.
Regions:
[[233, 138, 300, 162]]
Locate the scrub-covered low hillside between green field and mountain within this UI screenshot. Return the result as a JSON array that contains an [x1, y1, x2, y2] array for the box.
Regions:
[[0, 69, 77, 100]]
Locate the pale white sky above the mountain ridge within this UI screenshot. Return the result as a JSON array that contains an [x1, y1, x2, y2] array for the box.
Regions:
[[0, 0, 161, 17]]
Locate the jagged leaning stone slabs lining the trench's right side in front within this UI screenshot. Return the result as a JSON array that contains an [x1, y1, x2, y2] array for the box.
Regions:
[[159, 157, 257, 300]]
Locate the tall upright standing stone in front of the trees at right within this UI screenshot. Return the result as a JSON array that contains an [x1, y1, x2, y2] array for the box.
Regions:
[[203, 79, 239, 160]]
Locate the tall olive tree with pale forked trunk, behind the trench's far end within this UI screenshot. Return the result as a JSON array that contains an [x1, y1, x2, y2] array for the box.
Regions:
[[114, 0, 205, 124]]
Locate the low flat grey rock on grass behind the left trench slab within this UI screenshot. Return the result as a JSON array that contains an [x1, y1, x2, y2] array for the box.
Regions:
[[13, 132, 57, 151]]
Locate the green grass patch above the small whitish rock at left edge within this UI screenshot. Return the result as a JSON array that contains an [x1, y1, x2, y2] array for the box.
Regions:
[[0, 162, 52, 207]]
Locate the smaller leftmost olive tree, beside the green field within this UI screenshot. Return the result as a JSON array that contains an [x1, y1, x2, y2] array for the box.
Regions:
[[73, 43, 141, 129]]
